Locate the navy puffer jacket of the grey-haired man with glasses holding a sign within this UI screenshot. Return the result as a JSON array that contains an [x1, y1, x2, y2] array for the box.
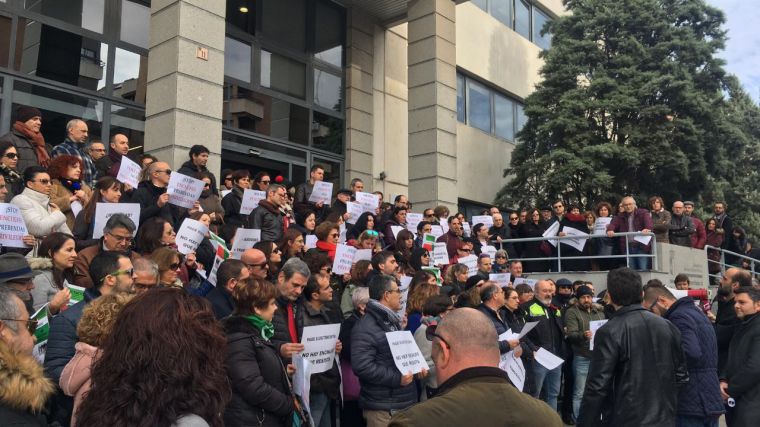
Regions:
[[351, 300, 417, 411]]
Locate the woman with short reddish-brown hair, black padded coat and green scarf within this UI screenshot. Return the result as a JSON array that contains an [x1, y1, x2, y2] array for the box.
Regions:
[[223, 277, 295, 427]]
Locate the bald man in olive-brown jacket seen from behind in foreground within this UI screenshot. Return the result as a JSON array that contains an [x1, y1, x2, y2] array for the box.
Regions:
[[388, 308, 563, 427]]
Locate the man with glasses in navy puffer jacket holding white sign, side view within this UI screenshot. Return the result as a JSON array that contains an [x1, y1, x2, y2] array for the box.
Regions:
[[351, 274, 427, 427]]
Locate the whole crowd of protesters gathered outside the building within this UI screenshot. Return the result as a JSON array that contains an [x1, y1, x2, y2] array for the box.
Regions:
[[0, 107, 760, 427]]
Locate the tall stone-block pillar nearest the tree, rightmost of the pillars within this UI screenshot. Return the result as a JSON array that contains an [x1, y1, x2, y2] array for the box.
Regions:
[[407, 0, 458, 212]]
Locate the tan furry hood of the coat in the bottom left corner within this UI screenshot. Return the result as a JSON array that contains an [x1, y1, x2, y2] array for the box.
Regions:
[[0, 340, 54, 427]]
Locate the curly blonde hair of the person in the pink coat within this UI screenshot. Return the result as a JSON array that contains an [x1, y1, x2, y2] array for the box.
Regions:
[[77, 293, 134, 347]]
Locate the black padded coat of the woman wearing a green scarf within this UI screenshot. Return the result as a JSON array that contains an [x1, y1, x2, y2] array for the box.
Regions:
[[222, 316, 295, 427]]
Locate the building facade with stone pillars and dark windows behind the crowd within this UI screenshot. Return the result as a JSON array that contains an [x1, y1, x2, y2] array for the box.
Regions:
[[0, 0, 563, 212]]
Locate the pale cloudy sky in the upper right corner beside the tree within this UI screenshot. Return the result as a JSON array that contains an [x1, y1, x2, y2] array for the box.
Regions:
[[707, 0, 760, 102]]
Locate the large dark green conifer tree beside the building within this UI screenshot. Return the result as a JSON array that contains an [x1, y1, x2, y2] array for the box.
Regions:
[[496, 0, 760, 237]]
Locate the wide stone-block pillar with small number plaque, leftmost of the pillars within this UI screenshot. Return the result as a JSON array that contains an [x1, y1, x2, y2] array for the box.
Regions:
[[145, 0, 225, 179]]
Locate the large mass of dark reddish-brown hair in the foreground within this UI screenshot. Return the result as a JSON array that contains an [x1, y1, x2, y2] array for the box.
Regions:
[[77, 288, 231, 427]]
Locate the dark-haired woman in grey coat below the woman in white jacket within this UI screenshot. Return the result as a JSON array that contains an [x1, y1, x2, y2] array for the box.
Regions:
[[29, 233, 77, 314]]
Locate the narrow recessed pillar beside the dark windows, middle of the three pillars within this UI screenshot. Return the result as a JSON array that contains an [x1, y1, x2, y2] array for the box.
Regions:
[[345, 8, 375, 191]]
